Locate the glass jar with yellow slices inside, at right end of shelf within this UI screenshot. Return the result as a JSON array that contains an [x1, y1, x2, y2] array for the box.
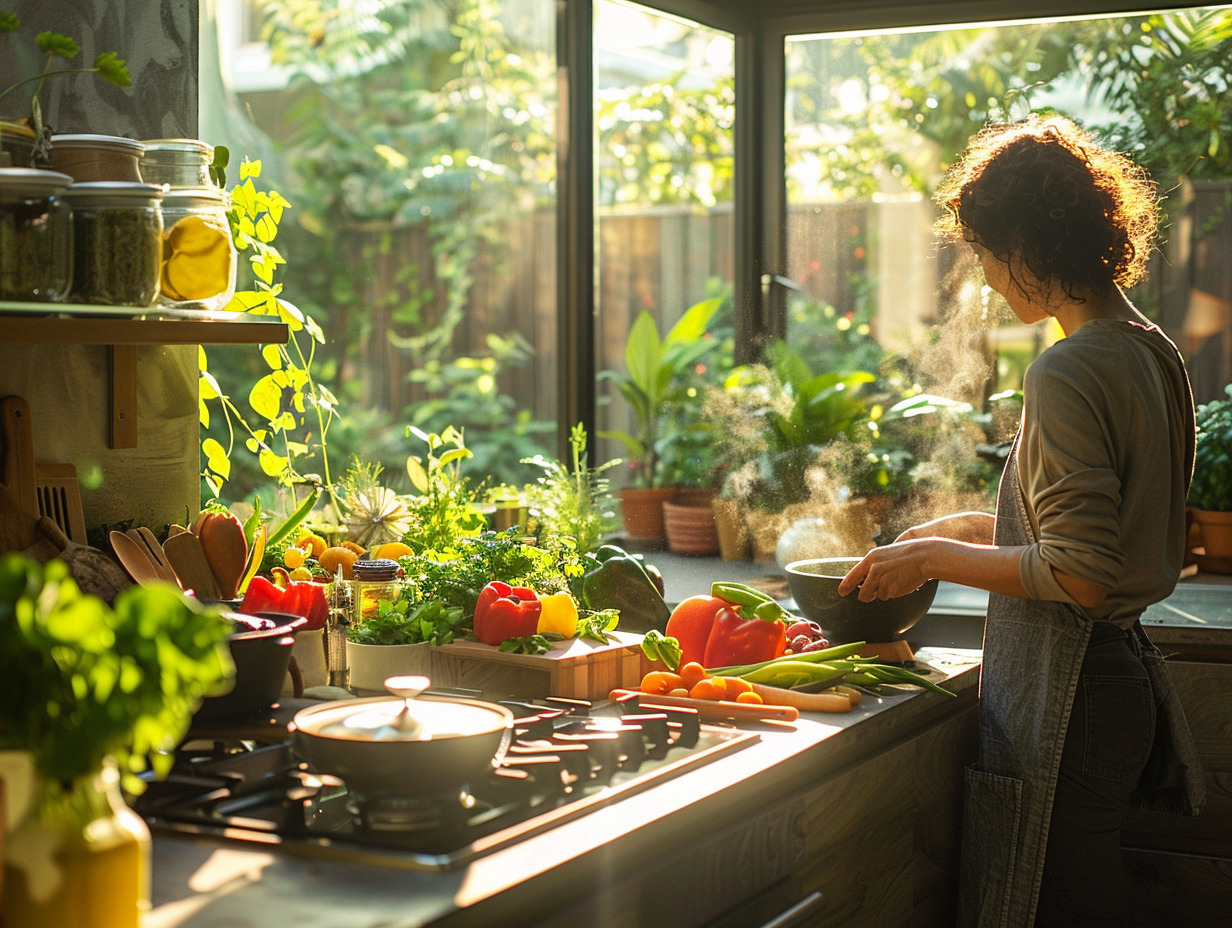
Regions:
[[158, 187, 237, 309]]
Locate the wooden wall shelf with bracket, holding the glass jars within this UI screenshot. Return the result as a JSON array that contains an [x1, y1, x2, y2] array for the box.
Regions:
[[0, 302, 290, 449]]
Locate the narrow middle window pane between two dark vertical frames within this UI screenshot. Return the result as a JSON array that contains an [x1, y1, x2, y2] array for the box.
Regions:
[[595, 0, 734, 484]]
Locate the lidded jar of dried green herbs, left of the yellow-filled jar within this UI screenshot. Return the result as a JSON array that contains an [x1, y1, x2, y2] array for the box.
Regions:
[[64, 181, 163, 307]]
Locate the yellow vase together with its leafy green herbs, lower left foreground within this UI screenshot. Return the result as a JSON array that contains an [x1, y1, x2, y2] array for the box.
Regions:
[[0, 555, 234, 928]]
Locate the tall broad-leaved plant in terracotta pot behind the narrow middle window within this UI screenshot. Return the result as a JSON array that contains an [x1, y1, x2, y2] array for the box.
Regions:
[[599, 297, 723, 545]]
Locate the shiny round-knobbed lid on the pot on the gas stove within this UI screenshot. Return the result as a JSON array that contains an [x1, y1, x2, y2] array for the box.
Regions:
[[293, 678, 514, 742]]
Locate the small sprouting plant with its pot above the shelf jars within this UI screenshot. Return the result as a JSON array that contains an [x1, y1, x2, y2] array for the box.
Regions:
[[0, 12, 133, 168]]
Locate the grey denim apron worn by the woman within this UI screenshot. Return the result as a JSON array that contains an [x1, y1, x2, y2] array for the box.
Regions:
[[958, 441, 1093, 928]]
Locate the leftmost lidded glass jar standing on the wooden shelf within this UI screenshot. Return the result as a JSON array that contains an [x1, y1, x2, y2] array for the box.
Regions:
[[0, 168, 73, 303]]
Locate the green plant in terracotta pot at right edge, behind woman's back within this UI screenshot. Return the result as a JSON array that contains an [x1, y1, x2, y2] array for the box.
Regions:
[[1188, 383, 1232, 564]]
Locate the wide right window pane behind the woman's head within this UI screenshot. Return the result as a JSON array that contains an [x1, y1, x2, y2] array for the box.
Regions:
[[785, 9, 1232, 405]]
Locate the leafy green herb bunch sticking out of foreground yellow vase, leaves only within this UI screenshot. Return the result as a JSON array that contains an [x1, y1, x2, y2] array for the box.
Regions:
[[0, 555, 234, 790]]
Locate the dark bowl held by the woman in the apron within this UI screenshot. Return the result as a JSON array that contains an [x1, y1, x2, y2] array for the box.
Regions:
[[785, 557, 936, 643]]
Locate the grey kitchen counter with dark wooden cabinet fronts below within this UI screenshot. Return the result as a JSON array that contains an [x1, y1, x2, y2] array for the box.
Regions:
[[144, 556, 1232, 928]]
